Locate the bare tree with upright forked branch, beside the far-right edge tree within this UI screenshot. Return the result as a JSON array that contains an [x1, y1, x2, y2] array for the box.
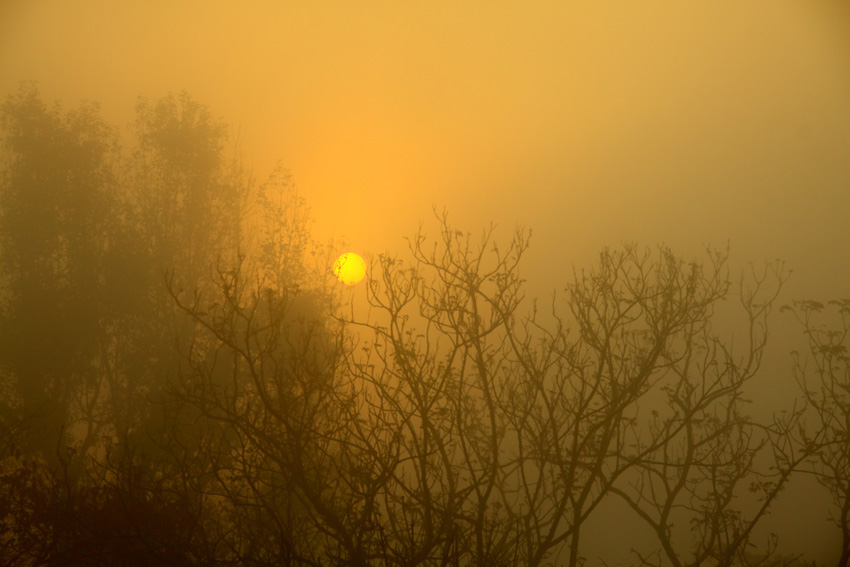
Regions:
[[613, 264, 807, 566]]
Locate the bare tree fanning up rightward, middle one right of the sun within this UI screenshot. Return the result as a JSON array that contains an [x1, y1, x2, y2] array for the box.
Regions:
[[504, 247, 724, 565]]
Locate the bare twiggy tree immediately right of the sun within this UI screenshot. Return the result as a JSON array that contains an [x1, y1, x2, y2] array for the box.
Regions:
[[350, 215, 527, 565]]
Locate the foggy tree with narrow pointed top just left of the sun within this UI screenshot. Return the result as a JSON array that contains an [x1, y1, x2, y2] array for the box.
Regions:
[[161, 171, 340, 565]]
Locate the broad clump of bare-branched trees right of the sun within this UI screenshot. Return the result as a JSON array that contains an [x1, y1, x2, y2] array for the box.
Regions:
[[342, 220, 803, 565]]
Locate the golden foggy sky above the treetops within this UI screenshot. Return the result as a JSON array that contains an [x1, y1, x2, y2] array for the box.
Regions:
[[0, 0, 850, 564]]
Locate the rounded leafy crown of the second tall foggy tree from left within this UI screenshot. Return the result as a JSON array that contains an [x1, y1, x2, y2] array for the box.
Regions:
[[129, 93, 246, 287]]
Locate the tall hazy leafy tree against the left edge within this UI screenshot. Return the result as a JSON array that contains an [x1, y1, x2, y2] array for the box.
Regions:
[[0, 87, 121, 464]]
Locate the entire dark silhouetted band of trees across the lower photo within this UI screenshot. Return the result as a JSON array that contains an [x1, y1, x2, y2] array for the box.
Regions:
[[0, 87, 850, 567]]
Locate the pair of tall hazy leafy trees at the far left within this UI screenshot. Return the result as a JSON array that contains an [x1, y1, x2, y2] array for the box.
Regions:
[[0, 86, 255, 564]]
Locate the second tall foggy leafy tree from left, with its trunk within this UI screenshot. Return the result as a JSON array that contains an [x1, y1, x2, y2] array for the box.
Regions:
[[116, 93, 251, 426]]
